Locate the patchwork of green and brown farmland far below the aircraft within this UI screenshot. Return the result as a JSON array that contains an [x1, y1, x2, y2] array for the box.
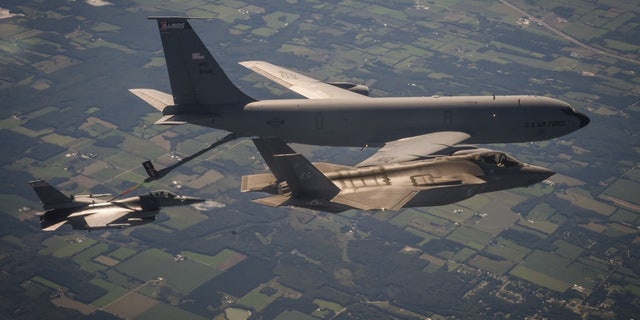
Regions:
[[0, 0, 640, 320]]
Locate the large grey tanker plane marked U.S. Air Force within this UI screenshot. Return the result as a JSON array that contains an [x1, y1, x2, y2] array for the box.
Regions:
[[130, 17, 589, 167]]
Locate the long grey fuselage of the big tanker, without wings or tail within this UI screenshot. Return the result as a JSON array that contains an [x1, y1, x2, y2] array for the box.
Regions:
[[216, 96, 583, 146]]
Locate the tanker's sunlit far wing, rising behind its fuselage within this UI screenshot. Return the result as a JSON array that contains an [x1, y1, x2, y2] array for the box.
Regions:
[[240, 61, 367, 99]]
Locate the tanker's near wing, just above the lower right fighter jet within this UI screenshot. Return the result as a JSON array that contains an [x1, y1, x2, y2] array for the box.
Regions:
[[357, 131, 471, 167]]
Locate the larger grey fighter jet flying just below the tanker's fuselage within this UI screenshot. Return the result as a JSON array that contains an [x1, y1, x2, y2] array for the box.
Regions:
[[241, 138, 555, 212]]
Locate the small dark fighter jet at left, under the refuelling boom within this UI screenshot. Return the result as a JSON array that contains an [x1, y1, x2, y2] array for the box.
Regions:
[[29, 180, 204, 231]]
